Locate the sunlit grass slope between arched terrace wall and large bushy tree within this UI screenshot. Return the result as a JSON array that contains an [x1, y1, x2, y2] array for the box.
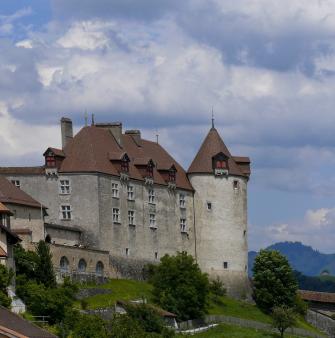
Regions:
[[78, 279, 152, 309]]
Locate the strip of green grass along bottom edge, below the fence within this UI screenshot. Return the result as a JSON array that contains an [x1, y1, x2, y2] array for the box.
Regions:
[[177, 324, 297, 338]]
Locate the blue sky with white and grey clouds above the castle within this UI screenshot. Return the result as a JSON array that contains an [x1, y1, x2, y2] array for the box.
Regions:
[[0, 0, 335, 252]]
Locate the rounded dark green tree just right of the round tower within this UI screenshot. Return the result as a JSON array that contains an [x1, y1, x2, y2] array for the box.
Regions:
[[253, 250, 298, 313]]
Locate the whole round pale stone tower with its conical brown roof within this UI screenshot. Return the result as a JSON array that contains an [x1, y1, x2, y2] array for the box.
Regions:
[[188, 125, 250, 297]]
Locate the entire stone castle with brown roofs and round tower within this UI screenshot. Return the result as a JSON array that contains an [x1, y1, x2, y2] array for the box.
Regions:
[[0, 118, 250, 295]]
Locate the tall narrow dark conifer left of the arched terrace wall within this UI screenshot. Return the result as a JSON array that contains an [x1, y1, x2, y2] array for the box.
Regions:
[[36, 241, 56, 288]]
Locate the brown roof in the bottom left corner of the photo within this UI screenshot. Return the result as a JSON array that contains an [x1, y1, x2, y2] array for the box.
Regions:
[[0, 305, 57, 338]]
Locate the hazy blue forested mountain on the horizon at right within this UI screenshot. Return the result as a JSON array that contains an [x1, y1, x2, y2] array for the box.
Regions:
[[249, 242, 335, 276]]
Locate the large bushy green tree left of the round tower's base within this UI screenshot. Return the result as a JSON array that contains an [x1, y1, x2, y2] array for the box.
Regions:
[[150, 252, 209, 320]]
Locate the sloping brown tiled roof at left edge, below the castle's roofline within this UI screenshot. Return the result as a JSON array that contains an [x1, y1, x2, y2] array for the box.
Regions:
[[0, 176, 45, 208]]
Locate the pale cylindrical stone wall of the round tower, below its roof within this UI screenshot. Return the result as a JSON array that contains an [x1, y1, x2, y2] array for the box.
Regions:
[[190, 174, 249, 295]]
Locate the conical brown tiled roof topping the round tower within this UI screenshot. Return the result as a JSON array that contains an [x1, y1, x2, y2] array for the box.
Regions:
[[187, 127, 250, 176]]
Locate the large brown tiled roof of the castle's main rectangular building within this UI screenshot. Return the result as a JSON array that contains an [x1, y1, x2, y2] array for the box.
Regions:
[[59, 126, 193, 190]]
